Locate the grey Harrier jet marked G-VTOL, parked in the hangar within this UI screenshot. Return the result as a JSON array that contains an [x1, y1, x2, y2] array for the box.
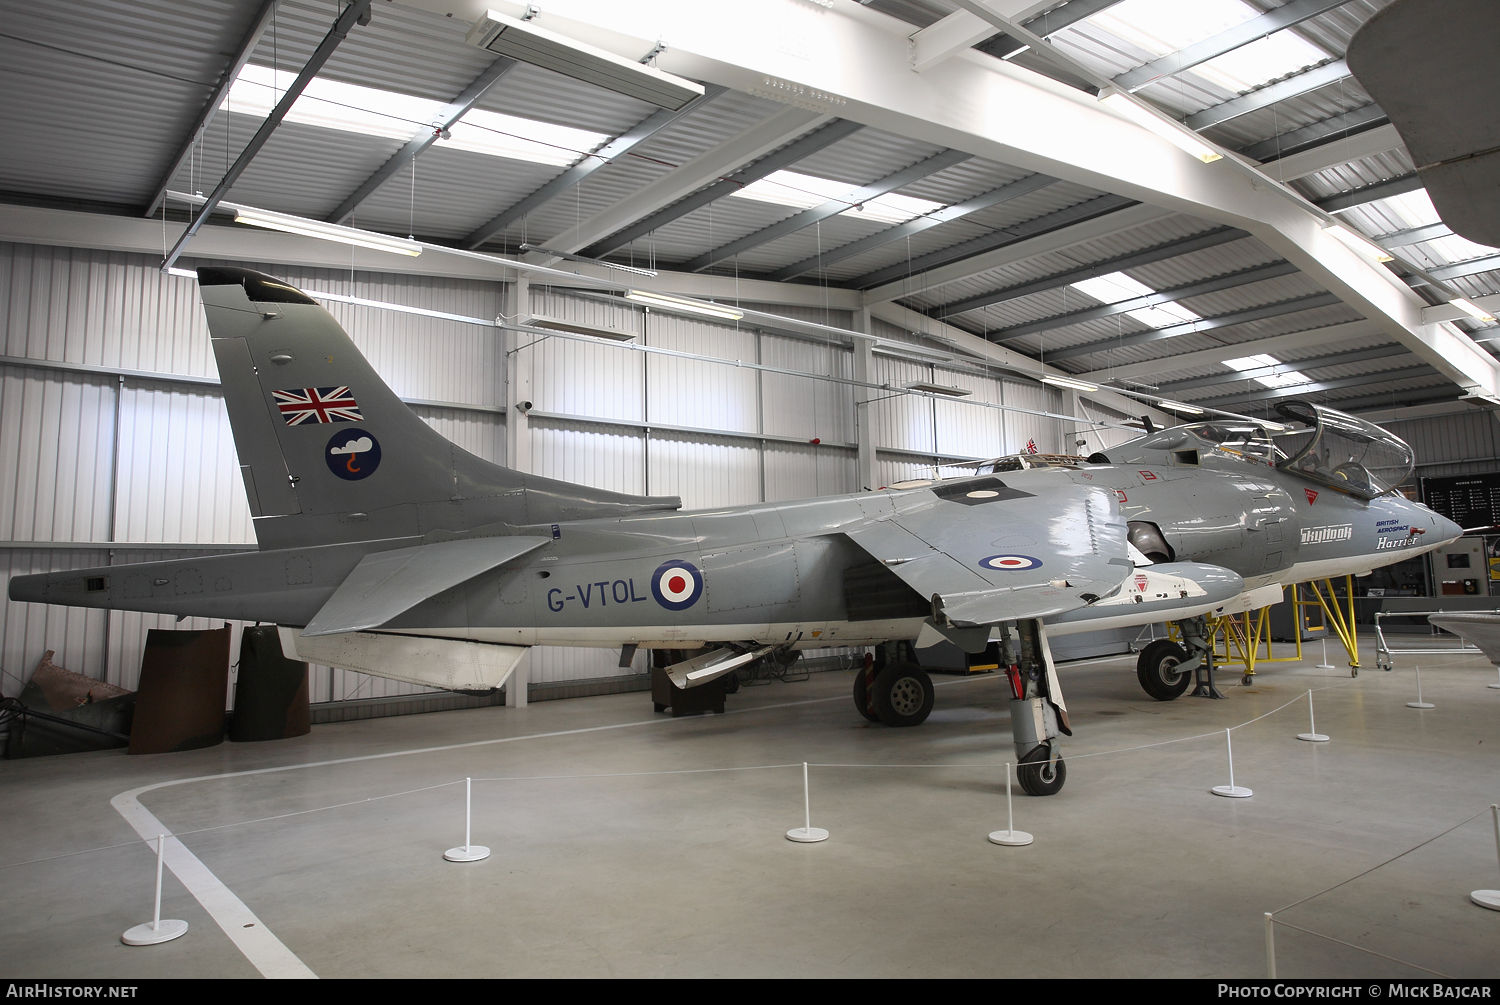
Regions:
[[11, 269, 1461, 794]]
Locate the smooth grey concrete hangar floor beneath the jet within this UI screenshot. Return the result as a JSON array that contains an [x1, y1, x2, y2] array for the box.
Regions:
[[0, 642, 1500, 978]]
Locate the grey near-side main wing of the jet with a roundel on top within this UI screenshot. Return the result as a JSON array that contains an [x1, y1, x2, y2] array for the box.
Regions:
[[845, 479, 1133, 624]]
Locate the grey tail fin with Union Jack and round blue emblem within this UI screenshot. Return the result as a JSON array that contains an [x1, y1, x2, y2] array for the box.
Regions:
[[198, 267, 681, 548]]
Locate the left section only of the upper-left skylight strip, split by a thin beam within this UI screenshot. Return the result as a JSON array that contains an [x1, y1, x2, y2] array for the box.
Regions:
[[219, 63, 443, 140]]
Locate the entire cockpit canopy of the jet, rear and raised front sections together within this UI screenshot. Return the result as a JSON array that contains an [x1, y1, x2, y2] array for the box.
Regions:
[[1109, 401, 1415, 500]]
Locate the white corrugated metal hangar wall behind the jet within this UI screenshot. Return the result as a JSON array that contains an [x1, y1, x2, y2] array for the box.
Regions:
[[0, 235, 1152, 701]]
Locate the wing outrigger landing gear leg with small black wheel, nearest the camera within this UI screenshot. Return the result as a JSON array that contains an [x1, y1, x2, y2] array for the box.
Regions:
[[1001, 618, 1073, 795]]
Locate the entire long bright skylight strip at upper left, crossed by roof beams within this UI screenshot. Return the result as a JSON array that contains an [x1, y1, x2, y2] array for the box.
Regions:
[[221, 63, 609, 167]]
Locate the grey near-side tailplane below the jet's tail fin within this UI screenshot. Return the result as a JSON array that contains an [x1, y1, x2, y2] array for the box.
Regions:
[[302, 537, 552, 636]]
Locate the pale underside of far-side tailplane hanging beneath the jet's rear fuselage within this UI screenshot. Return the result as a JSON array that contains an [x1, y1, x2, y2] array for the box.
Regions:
[[281, 629, 527, 692]]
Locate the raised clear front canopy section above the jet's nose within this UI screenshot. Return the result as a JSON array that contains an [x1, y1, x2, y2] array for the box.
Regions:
[[1272, 401, 1416, 500]]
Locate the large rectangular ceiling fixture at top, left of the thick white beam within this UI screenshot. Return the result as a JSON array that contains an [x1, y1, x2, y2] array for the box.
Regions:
[[464, 11, 704, 111]]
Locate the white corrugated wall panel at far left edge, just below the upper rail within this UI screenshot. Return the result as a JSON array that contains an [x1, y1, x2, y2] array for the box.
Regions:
[[0, 366, 116, 542]]
